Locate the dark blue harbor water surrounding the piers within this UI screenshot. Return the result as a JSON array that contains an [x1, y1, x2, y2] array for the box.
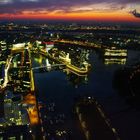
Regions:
[[32, 49, 140, 140]]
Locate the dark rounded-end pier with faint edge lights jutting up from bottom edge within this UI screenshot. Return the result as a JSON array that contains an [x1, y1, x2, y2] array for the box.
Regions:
[[75, 96, 120, 140]]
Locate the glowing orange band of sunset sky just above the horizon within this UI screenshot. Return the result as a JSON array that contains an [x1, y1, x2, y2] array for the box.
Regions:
[[0, 11, 140, 22]]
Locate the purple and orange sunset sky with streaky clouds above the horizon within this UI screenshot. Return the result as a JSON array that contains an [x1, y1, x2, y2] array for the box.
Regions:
[[0, 0, 140, 22]]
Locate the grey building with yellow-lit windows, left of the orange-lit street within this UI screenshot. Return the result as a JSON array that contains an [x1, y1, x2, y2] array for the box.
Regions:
[[4, 91, 29, 125]]
